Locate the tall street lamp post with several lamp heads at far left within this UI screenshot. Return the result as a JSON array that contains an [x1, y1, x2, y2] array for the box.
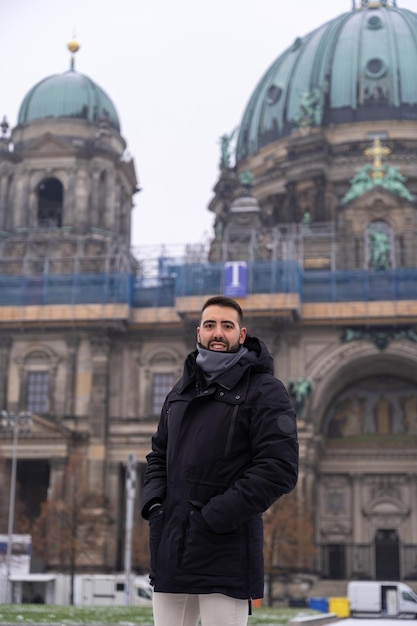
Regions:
[[1, 410, 32, 604]]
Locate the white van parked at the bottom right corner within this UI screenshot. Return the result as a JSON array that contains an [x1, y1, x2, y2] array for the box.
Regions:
[[347, 580, 417, 618]]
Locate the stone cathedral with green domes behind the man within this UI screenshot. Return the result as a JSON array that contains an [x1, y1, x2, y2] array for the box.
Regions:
[[0, 0, 417, 596]]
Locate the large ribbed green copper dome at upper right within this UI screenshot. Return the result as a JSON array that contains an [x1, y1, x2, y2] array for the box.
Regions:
[[236, 0, 417, 162]]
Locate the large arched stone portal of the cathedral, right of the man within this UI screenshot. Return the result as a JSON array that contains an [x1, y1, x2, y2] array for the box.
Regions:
[[308, 339, 417, 578]]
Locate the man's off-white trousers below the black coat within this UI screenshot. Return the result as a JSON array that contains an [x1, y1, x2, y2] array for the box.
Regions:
[[153, 592, 248, 626]]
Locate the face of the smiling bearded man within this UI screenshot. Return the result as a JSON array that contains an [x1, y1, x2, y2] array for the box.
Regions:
[[197, 305, 246, 352]]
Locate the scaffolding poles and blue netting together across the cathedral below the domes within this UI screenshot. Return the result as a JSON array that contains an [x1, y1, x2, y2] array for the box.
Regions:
[[0, 223, 417, 307]]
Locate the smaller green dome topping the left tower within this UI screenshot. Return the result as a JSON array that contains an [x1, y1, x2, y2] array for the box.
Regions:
[[18, 69, 120, 132]]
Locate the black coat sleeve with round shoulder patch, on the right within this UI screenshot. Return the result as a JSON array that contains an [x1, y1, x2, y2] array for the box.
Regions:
[[201, 376, 298, 534]]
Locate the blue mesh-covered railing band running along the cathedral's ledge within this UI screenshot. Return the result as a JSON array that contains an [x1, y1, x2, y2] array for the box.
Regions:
[[0, 260, 417, 308]]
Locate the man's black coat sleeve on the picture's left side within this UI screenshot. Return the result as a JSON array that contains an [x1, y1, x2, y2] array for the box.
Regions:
[[141, 404, 168, 519]]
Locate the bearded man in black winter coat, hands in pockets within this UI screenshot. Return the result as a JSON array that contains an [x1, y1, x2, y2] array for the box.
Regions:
[[142, 296, 298, 626]]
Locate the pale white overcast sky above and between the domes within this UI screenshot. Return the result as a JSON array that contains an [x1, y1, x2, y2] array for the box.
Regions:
[[0, 0, 417, 246]]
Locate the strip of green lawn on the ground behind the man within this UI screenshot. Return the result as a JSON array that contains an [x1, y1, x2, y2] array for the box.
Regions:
[[0, 604, 318, 626]]
